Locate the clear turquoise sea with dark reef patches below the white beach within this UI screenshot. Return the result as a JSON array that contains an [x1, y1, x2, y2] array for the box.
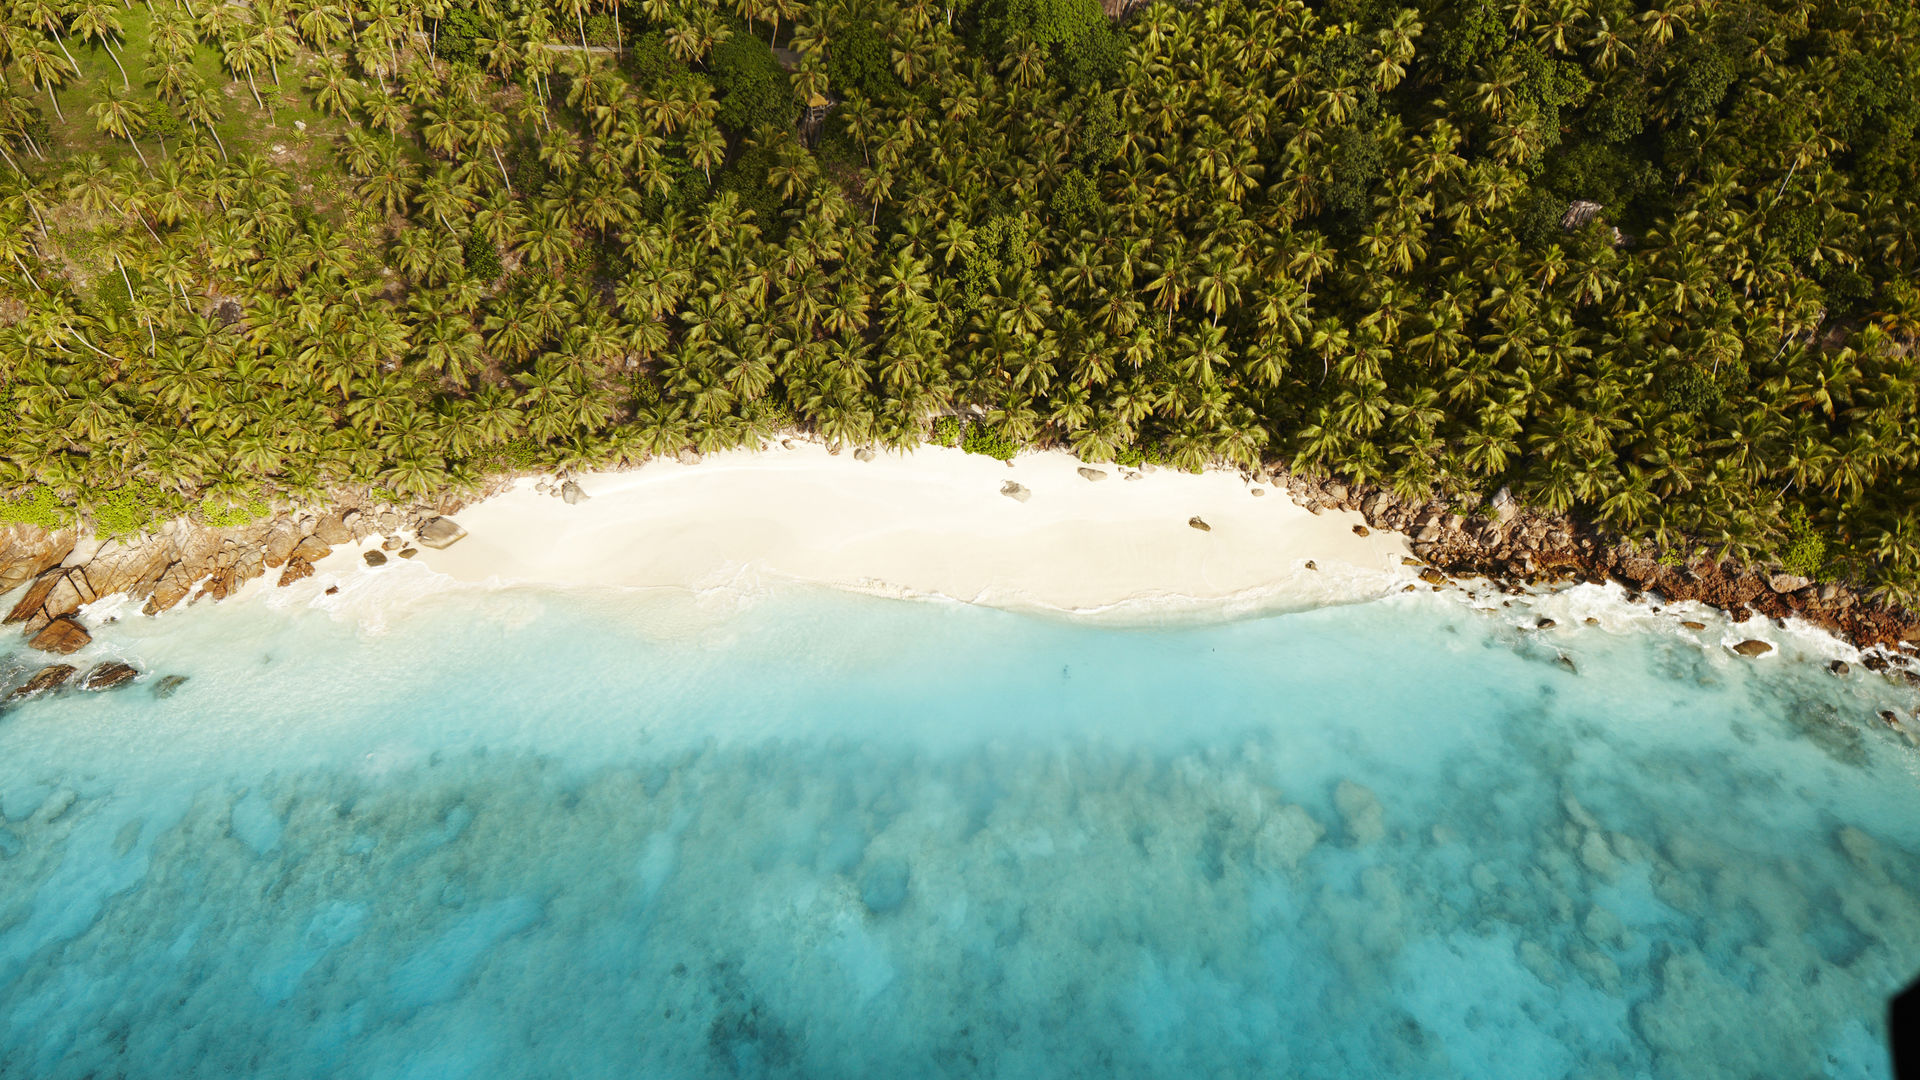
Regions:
[[0, 576, 1920, 1080]]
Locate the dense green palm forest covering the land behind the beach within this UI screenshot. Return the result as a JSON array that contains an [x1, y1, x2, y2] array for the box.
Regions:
[[0, 0, 1920, 601]]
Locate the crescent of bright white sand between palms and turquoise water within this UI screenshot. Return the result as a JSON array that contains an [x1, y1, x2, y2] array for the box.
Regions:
[[420, 442, 1407, 611]]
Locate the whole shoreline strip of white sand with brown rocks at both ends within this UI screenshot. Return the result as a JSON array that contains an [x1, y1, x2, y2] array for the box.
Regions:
[[0, 443, 1920, 686]]
